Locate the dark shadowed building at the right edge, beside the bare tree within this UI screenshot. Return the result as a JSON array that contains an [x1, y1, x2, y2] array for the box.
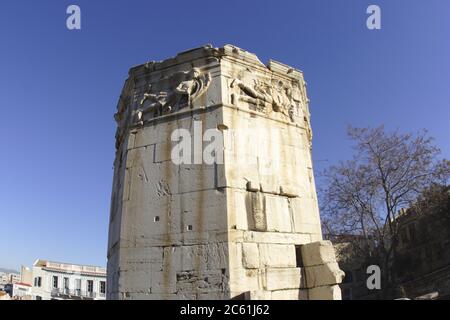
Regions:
[[395, 192, 450, 299]]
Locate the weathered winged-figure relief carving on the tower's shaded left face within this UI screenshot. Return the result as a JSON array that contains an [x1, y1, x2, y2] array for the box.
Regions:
[[136, 68, 211, 123]]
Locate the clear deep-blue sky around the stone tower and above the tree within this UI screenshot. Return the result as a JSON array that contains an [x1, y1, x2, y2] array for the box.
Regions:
[[0, 0, 450, 269]]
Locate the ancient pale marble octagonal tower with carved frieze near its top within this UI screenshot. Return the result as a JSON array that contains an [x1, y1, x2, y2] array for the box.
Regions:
[[107, 45, 343, 299]]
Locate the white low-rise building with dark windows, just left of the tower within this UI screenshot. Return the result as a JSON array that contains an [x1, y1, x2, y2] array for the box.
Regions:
[[32, 259, 106, 300]]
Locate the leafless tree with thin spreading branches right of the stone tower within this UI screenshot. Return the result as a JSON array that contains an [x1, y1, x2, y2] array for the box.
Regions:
[[319, 126, 449, 293]]
